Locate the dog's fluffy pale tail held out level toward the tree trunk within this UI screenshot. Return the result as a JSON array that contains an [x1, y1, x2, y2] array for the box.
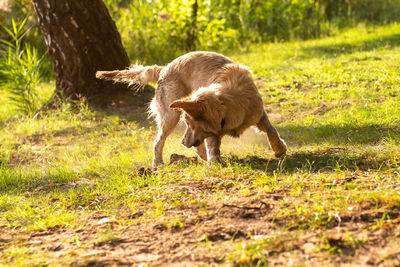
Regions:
[[96, 65, 163, 89]]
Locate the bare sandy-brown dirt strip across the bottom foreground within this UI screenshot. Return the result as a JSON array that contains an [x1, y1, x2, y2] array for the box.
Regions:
[[0, 193, 400, 266]]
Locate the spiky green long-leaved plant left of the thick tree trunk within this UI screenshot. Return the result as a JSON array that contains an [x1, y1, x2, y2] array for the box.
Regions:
[[0, 19, 43, 116]]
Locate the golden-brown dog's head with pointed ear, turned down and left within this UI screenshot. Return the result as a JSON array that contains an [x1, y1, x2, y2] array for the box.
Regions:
[[170, 90, 225, 148]]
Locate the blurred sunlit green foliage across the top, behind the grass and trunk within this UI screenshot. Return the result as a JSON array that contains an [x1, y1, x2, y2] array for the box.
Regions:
[[0, 0, 400, 65]]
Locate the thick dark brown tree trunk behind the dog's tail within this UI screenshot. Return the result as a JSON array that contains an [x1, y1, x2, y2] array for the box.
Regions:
[[33, 0, 129, 99]]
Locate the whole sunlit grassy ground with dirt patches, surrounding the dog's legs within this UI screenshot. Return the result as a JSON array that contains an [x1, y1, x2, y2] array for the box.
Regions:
[[0, 24, 400, 266]]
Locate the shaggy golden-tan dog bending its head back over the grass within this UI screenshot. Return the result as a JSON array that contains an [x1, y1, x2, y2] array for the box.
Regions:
[[96, 52, 286, 169]]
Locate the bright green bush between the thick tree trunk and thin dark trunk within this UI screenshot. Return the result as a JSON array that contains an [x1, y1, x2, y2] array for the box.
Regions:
[[106, 0, 198, 64]]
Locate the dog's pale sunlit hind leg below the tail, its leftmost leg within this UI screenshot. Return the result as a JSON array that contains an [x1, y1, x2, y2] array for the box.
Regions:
[[152, 109, 180, 170]]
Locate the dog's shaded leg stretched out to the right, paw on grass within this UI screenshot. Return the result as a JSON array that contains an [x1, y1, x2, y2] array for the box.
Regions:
[[257, 111, 287, 157]]
